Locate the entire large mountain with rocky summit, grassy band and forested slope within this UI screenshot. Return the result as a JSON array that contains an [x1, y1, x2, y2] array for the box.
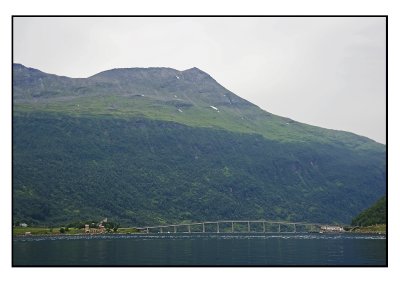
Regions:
[[13, 64, 386, 225]]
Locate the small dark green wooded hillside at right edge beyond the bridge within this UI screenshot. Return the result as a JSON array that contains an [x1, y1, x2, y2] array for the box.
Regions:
[[351, 196, 387, 226]]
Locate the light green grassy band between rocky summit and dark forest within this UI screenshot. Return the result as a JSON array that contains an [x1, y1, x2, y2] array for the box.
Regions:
[[14, 96, 385, 153]]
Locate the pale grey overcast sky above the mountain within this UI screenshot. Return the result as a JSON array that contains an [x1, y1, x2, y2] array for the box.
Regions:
[[14, 17, 386, 143]]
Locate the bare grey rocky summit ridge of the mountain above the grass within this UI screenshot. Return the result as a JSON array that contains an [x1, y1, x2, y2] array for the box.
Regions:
[[13, 64, 254, 108]]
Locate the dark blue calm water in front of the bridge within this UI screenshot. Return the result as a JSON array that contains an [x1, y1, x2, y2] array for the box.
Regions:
[[13, 234, 387, 266]]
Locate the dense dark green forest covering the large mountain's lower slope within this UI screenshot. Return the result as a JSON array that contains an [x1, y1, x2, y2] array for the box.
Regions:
[[13, 114, 385, 225]]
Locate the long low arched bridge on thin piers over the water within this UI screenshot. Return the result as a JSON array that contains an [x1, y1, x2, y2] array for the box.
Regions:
[[135, 220, 343, 233]]
